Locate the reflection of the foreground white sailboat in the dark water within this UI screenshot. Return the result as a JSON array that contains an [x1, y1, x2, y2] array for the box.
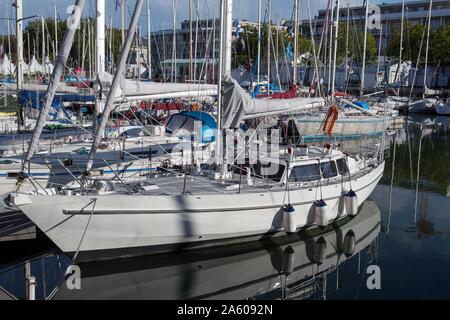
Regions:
[[53, 201, 381, 299]]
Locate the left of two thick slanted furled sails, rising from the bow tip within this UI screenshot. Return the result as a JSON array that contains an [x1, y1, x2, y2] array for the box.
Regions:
[[22, 0, 86, 170]]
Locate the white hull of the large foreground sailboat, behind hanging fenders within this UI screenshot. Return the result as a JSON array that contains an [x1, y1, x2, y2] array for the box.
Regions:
[[16, 163, 384, 259]]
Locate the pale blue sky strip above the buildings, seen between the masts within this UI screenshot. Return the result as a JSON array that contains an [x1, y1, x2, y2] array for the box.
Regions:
[[0, 0, 401, 35]]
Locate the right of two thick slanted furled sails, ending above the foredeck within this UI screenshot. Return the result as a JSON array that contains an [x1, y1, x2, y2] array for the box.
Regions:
[[86, 0, 144, 172]]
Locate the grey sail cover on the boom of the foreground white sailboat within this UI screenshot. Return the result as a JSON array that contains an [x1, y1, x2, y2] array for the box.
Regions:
[[222, 76, 325, 129]]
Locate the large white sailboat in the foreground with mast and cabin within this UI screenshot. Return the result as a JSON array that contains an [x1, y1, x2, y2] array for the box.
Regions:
[[10, 0, 384, 259]]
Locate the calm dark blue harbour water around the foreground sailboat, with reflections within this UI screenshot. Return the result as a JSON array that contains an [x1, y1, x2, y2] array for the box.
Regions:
[[0, 117, 450, 299]]
